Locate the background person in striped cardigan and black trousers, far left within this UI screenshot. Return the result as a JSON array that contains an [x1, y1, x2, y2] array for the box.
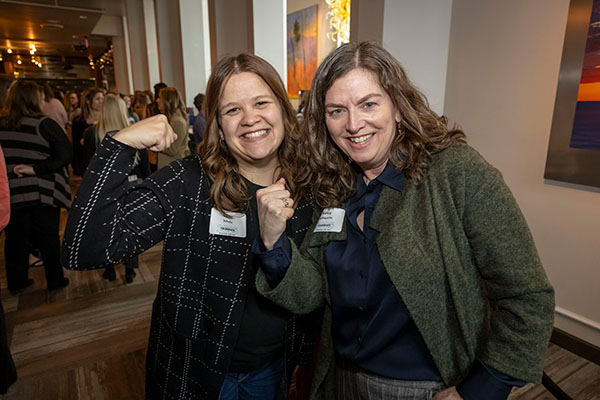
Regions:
[[0, 80, 72, 293]]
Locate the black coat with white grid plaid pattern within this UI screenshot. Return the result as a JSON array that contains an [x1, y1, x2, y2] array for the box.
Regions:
[[62, 137, 315, 399]]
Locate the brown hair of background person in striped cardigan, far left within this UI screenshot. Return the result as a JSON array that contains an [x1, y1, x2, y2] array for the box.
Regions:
[[0, 79, 44, 130]]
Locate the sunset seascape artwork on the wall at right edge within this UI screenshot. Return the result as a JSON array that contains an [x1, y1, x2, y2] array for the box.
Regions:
[[544, 0, 600, 188]]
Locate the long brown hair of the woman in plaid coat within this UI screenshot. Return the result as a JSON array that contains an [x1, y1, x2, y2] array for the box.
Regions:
[[199, 53, 304, 212]]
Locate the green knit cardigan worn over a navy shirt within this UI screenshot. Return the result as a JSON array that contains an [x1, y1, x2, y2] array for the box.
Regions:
[[256, 144, 554, 400]]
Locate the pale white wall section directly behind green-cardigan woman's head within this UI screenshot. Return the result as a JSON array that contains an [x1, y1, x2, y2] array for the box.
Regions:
[[383, 0, 452, 114]]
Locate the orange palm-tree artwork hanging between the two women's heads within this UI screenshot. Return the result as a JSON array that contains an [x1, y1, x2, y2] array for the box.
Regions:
[[287, 5, 317, 98]]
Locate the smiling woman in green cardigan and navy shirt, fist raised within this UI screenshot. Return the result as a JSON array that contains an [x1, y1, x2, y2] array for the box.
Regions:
[[254, 43, 554, 400]]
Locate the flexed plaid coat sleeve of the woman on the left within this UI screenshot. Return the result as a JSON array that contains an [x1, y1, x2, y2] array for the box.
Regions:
[[61, 137, 182, 270]]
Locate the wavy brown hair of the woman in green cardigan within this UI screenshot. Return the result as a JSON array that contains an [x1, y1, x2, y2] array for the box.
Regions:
[[297, 42, 465, 207]]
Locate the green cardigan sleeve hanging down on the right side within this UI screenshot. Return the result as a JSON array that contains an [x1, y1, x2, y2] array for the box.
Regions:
[[462, 147, 554, 381]]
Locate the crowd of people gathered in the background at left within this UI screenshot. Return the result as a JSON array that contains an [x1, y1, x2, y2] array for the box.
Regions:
[[0, 77, 204, 293]]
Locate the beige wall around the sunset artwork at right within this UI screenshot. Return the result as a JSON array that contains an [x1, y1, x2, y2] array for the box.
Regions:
[[445, 0, 600, 346]]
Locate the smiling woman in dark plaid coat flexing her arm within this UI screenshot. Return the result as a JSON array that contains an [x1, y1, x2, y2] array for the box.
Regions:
[[63, 54, 320, 400]]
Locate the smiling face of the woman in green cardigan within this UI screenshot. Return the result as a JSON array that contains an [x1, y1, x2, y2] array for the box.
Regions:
[[325, 69, 400, 180]]
